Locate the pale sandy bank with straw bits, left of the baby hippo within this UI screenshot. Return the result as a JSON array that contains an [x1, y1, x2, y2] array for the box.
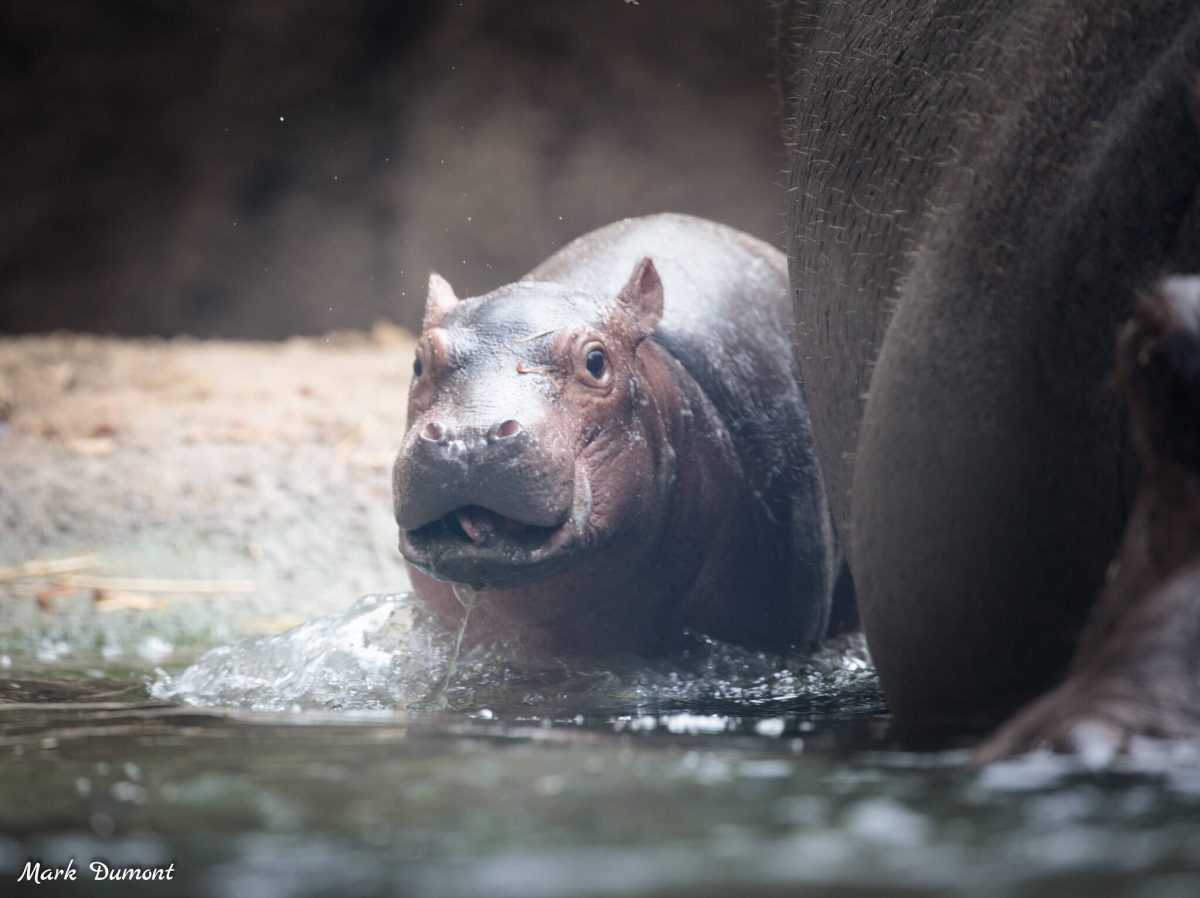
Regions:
[[0, 325, 413, 661]]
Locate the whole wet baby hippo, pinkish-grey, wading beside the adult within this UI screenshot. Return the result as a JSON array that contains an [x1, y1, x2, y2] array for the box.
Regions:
[[394, 215, 835, 654]]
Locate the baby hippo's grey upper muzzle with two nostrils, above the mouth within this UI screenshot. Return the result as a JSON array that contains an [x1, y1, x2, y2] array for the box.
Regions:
[[392, 415, 575, 538]]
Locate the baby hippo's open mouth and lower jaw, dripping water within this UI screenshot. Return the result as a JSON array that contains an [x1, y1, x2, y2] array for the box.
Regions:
[[400, 477, 592, 589]]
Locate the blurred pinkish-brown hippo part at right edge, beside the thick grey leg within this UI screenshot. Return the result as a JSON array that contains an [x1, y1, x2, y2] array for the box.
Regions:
[[977, 277, 1200, 764]]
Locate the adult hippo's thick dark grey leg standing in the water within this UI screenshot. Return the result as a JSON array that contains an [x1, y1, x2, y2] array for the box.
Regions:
[[850, 45, 1200, 724]]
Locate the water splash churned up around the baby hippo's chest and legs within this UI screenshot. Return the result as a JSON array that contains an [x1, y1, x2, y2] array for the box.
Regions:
[[150, 594, 883, 729]]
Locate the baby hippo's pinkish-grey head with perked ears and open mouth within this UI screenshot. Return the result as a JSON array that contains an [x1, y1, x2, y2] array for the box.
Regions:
[[392, 259, 662, 589]]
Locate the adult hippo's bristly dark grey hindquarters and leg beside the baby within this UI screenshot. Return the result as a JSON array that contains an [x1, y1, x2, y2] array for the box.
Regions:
[[780, 0, 1200, 720]]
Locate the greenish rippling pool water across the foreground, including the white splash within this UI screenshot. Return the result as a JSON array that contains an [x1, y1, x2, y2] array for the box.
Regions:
[[0, 597, 1200, 898]]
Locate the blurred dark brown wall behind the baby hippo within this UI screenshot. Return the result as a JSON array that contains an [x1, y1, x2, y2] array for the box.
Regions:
[[0, 0, 785, 337]]
